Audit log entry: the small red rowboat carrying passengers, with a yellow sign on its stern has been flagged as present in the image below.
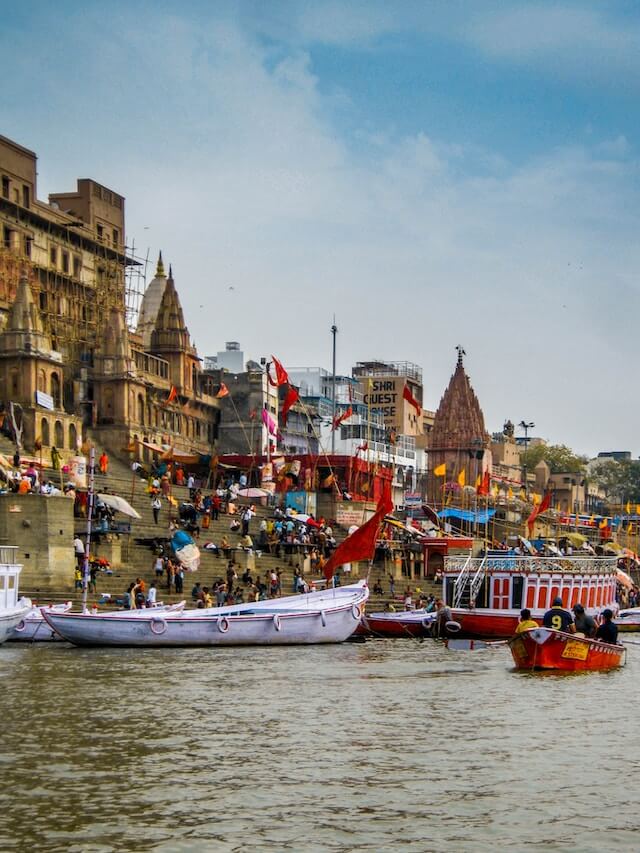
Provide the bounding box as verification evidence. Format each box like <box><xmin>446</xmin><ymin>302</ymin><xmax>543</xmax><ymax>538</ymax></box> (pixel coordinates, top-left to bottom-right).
<box><xmin>509</xmin><ymin>628</ymin><xmax>626</xmax><ymax>672</ymax></box>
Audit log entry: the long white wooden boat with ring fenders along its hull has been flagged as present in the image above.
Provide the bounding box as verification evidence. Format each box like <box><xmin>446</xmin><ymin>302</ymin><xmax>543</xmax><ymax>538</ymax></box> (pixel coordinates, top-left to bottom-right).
<box><xmin>44</xmin><ymin>581</ymin><xmax>369</xmax><ymax>646</ymax></box>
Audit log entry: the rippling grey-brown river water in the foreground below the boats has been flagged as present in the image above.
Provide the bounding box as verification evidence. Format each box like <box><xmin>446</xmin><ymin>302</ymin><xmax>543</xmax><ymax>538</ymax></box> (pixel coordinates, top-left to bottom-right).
<box><xmin>0</xmin><ymin>640</ymin><xmax>640</xmax><ymax>853</ymax></box>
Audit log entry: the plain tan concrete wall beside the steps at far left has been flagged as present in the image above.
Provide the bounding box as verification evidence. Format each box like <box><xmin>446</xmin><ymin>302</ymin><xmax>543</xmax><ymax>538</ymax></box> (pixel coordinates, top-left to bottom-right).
<box><xmin>0</xmin><ymin>494</ymin><xmax>75</xmax><ymax>592</ymax></box>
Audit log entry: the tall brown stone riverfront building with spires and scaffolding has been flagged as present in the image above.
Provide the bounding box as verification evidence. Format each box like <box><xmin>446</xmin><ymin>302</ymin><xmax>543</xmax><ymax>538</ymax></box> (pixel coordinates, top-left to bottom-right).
<box><xmin>0</xmin><ymin>137</ymin><xmax>218</xmax><ymax>458</ymax></box>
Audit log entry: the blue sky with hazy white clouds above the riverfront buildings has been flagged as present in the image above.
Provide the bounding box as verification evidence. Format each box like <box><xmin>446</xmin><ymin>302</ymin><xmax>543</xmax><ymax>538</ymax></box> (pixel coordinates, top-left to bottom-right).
<box><xmin>0</xmin><ymin>0</ymin><xmax>640</xmax><ymax>456</ymax></box>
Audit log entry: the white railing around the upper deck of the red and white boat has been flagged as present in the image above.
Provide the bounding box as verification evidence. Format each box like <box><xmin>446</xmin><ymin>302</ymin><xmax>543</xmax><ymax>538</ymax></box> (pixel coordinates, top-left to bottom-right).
<box><xmin>444</xmin><ymin>554</ymin><xmax>618</xmax><ymax>576</ymax></box>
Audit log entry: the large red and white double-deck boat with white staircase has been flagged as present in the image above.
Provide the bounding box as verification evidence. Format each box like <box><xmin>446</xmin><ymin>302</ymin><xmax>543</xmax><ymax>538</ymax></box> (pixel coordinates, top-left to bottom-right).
<box><xmin>443</xmin><ymin>554</ymin><xmax>618</xmax><ymax>639</ymax></box>
